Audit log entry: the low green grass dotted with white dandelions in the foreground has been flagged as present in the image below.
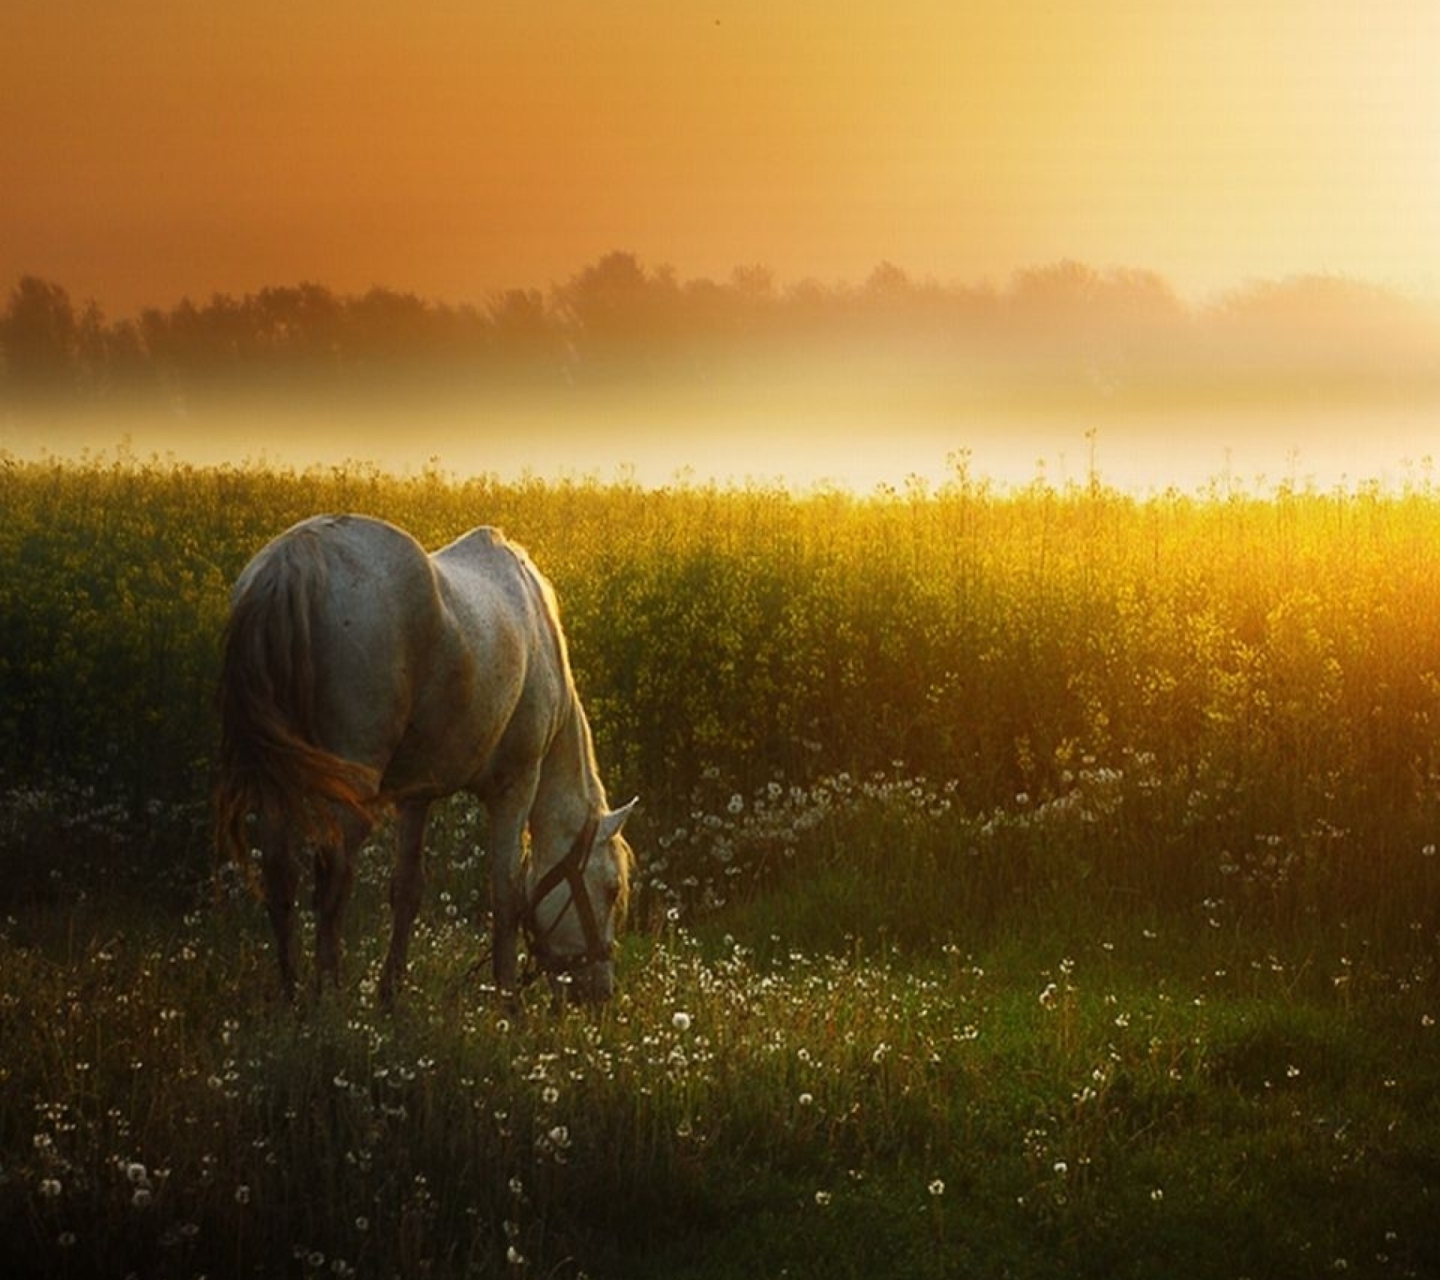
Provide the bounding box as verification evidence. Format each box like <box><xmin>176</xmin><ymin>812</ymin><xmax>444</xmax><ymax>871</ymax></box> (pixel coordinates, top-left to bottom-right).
<box><xmin>0</xmin><ymin>789</ymin><xmax>1440</xmax><ymax>1277</ymax></box>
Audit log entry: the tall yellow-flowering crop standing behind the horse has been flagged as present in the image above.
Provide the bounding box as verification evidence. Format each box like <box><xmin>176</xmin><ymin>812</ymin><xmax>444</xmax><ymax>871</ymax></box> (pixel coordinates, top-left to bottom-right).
<box><xmin>8</xmin><ymin>455</ymin><xmax>1440</xmax><ymax>831</ymax></box>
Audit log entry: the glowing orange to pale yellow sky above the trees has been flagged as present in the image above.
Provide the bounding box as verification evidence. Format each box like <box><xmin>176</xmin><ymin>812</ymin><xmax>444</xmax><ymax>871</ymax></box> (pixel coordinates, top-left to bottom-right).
<box><xmin>0</xmin><ymin>0</ymin><xmax>1440</xmax><ymax>315</ymax></box>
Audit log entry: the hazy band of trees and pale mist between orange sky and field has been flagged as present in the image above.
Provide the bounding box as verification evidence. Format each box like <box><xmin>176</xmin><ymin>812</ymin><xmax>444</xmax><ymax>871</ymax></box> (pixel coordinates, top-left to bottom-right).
<box><xmin>0</xmin><ymin>252</ymin><xmax>1440</xmax><ymax>492</ymax></box>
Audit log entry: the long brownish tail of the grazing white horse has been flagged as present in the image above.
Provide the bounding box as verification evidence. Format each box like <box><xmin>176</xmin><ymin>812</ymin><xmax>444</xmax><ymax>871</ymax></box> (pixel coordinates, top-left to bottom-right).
<box><xmin>215</xmin><ymin>538</ymin><xmax>379</xmax><ymax>867</ymax></box>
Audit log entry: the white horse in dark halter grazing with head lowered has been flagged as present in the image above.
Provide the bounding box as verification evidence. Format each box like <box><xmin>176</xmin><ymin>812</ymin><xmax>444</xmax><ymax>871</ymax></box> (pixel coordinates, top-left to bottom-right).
<box><xmin>216</xmin><ymin>515</ymin><xmax>636</xmax><ymax>1004</ymax></box>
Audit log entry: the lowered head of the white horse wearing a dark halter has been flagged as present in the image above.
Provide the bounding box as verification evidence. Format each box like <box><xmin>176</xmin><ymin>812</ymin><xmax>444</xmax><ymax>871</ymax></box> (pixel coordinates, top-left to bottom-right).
<box><xmin>526</xmin><ymin>801</ymin><xmax>636</xmax><ymax>1002</ymax></box>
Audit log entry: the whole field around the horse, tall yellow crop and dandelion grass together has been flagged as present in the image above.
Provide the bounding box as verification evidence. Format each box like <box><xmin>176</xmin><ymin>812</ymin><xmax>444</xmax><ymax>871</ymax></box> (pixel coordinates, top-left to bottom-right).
<box><xmin>0</xmin><ymin>455</ymin><xmax>1440</xmax><ymax>1280</ymax></box>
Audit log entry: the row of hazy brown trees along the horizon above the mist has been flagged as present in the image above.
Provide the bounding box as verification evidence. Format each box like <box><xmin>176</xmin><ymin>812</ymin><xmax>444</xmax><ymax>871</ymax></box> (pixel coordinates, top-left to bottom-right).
<box><xmin>0</xmin><ymin>252</ymin><xmax>1440</xmax><ymax>402</ymax></box>
